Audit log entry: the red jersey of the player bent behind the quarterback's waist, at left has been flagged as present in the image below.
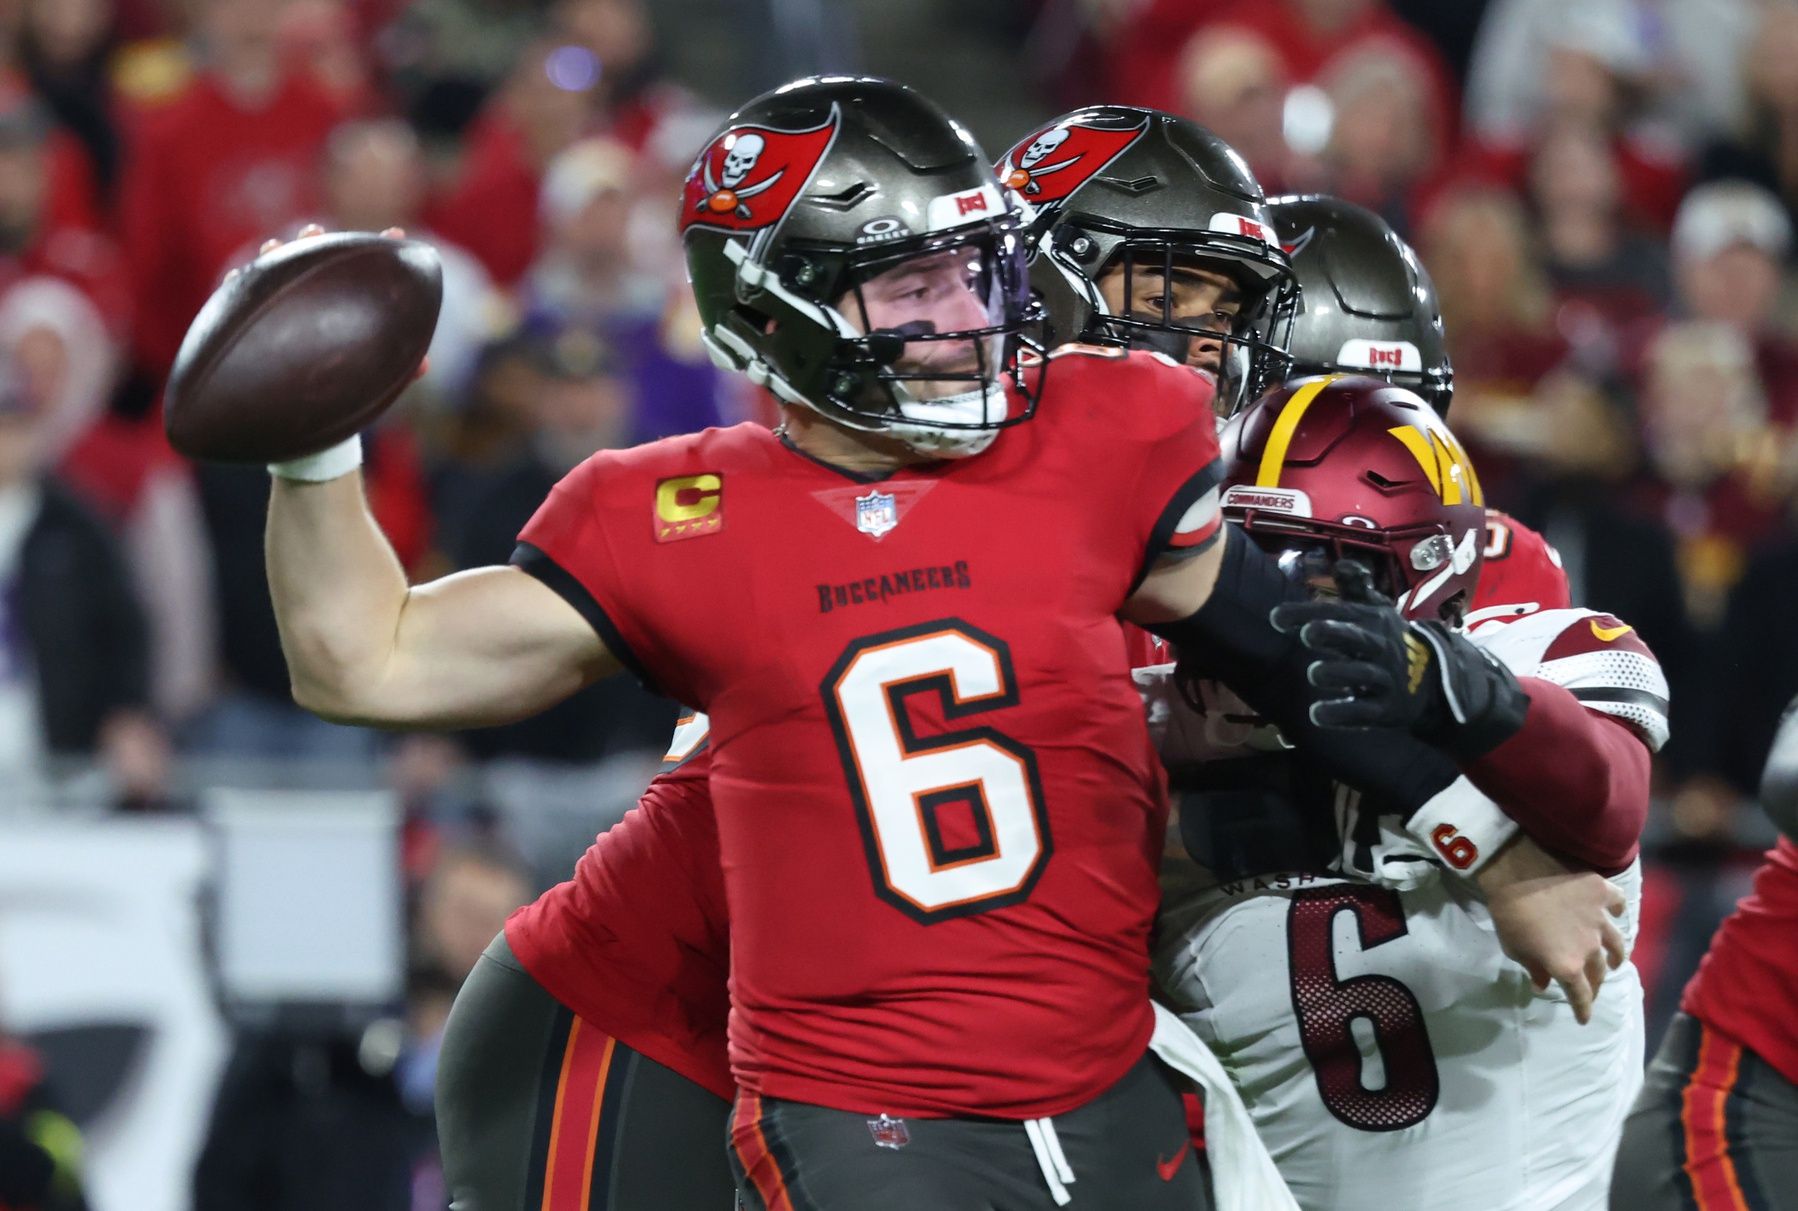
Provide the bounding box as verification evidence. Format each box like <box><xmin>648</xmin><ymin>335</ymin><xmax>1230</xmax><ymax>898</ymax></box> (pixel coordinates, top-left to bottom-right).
<box><xmin>505</xmin><ymin>715</ymin><xmax>735</xmax><ymax>1101</ymax></box>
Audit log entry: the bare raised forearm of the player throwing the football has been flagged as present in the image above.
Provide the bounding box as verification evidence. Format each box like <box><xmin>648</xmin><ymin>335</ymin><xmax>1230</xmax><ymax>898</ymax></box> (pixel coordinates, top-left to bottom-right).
<box><xmin>266</xmin><ymin>471</ymin><xmax>406</xmax><ymax>719</ymax></box>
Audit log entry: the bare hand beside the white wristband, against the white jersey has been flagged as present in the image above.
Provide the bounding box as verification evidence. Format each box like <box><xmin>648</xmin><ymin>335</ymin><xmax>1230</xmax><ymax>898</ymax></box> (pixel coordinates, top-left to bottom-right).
<box><xmin>1474</xmin><ymin>834</ymin><xmax>1625</xmax><ymax>1026</ymax></box>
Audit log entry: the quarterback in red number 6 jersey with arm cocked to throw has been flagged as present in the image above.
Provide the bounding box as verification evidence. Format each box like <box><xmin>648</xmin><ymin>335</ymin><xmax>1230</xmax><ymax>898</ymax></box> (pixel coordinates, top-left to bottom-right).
<box><xmin>268</xmin><ymin>77</ymin><xmax>1433</xmax><ymax>1207</ymax></box>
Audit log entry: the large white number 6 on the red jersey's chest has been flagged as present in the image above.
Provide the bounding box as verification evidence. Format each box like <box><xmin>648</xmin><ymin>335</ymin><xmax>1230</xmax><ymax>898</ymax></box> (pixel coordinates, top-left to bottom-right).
<box><xmin>822</xmin><ymin>620</ymin><xmax>1052</xmax><ymax>924</ymax></box>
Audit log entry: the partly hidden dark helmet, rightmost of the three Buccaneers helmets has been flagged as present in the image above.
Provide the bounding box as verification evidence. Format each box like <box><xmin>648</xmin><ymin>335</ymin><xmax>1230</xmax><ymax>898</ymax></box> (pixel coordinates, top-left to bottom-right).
<box><xmin>1268</xmin><ymin>194</ymin><xmax>1455</xmax><ymax>417</ymax></box>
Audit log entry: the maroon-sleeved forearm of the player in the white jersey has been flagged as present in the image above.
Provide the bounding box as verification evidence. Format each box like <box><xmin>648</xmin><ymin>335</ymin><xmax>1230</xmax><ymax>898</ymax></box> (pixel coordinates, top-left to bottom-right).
<box><xmin>1462</xmin><ymin>677</ymin><xmax>1649</xmax><ymax>871</ymax></box>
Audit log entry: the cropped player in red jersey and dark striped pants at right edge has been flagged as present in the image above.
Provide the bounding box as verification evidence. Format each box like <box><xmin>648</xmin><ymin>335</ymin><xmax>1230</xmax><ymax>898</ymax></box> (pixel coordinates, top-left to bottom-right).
<box><xmin>1611</xmin><ymin>703</ymin><xmax>1798</xmax><ymax>1211</ymax></box>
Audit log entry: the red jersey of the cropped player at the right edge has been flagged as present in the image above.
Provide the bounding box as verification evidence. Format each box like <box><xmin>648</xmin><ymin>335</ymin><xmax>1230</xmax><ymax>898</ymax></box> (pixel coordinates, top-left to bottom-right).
<box><xmin>1679</xmin><ymin>837</ymin><xmax>1798</xmax><ymax>1083</ymax></box>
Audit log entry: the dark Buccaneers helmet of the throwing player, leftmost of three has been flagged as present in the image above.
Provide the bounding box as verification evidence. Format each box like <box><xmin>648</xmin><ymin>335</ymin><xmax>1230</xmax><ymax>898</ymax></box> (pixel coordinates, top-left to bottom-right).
<box><xmin>680</xmin><ymin>75</ymin><xmax>1041</xmax><ymax>456</ymax></box>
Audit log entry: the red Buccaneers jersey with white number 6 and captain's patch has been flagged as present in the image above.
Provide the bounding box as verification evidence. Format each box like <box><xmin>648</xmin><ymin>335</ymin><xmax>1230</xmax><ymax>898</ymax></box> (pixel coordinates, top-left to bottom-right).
<box><xmin>516</xmin><ymin>346</ymin><xmax>1219</xmax><ymax>1118</ymax></box>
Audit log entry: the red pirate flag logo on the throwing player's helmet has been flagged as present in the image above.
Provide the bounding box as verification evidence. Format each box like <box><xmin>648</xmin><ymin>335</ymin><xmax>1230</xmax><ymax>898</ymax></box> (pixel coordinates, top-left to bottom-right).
<box><xmin>680</xmin><ymin>108</ymin><xmax>836</xmax><ymax>232</ymax></box>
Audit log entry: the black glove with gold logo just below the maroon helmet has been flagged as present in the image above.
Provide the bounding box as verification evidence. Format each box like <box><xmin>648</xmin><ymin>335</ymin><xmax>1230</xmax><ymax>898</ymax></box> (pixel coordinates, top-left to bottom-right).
<box><xmin>1273</xmin><ymin>559</ymin><xmax>1530</xmax><ymax>760</ymax></box>
